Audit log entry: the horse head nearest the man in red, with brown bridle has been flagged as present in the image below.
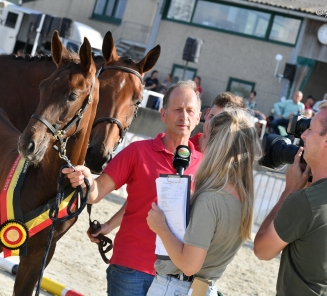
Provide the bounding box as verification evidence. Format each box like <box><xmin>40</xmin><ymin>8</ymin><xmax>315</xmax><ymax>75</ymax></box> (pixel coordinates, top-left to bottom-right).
<box><xmin>85</xmin><ymin>32</ymin><xmax>160</xmax><ymax>173</ymax></box>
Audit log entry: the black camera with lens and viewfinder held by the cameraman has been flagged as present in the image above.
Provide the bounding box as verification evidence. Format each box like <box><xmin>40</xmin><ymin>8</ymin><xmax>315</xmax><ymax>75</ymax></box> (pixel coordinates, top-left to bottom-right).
<box><xmin>259</xmin><ymin>115</ymin><xmax>311</xmax><ymax>170</ymax></box>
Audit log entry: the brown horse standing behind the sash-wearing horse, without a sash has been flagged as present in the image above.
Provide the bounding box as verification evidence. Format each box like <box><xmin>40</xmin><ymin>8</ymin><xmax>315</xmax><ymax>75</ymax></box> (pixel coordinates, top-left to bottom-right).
<box><xmin>0</xmin><ymin>32</ymin><xmax>160</xmax><ymax>173</ymax></box>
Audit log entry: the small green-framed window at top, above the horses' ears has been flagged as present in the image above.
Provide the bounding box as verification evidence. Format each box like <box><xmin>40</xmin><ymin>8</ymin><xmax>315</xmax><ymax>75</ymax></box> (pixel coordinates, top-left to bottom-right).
<box><xmin>92</xmin><ymin>0</ymin><xmax>127</xmax><ymax>24</ymax></box>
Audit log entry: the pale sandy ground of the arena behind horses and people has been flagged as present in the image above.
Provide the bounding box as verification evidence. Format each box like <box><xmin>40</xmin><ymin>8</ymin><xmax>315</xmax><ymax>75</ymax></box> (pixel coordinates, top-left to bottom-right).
<box><xmin>0</xmin><ymin>186</ymin><xmax>279</xmax><ymax>296</ymax></box>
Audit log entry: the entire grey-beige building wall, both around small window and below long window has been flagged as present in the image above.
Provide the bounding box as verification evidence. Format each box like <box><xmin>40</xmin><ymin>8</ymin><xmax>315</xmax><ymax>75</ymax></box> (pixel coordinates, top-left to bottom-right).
<box><xmin>24</xmin><ymin>0</ymin><xmax>300</xmax><ymax>115</ymax></box>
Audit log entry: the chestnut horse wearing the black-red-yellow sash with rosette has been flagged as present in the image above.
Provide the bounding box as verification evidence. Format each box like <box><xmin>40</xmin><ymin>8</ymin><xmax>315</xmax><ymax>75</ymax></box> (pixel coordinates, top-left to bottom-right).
<box><xmin>0</xmin><ymin>32</ymin><xmax>99</xmax><ymax>296</ymax></box>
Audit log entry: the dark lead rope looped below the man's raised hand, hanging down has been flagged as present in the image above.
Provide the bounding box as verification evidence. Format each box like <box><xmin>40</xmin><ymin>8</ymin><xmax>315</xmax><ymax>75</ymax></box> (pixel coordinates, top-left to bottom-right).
<box><xmin>35</xmin><ymin>163</ymin><xmax>90</xmax><ymax>296</ymax></box>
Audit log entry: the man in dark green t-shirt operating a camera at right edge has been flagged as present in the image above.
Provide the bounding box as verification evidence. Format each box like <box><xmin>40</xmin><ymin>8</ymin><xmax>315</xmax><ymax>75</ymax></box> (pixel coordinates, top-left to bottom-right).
<box><xmin>254</xmin><ymin>102</ymin><xmax>327</xmax><ymax>296</ymax></box>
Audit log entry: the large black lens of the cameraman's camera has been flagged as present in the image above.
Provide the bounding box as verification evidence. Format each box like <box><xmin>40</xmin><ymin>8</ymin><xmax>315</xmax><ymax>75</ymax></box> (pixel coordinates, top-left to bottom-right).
<box><xmin>259</xmin><ymin>133</ymin><xmax>305</xmax><ymax>170</ymax></box>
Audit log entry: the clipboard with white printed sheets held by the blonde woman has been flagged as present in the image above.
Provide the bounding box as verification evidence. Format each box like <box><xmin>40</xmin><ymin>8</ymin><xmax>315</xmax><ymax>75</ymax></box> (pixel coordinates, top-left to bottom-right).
<box><xmin>155</xmin><ymin>174</ymin><xmax>191</xmax><ymax>260</ymax></box>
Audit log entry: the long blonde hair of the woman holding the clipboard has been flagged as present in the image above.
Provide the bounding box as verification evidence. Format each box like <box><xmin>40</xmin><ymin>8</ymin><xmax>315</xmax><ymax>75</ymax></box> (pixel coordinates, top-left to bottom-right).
<box><xmin>193</xmin><ymin>108</ymin><xmax>261</xmax><ymax>241</ymax></box>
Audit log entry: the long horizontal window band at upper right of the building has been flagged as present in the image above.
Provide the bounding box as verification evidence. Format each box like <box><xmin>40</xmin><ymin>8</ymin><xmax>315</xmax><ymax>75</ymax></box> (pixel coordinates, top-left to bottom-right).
<box><xmin>164</xmin><ymin>0</ymin><xmax>302</xmax><ymax>46</ymax></box>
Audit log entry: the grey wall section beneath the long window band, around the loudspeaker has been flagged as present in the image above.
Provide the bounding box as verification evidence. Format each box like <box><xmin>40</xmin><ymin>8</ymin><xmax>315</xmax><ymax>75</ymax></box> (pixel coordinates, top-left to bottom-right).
<box><xmin>155</xmin><ymin>21</ymin><xmax>293</xmax><ymax>115</ymax></box>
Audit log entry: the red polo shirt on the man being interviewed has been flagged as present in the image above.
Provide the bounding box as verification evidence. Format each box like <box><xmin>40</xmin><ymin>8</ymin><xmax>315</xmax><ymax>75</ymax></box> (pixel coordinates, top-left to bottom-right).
<box><xmin>103</xmin><ymin>133</ymin><xmax>202</xmax><ymax>275</ymax></box>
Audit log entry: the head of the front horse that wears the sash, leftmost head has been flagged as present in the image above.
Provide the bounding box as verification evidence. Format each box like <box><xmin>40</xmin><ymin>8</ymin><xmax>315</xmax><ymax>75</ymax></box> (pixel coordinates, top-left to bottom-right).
<box><xmin>18</xmin><ymin>31</ymin><xmax>99</xmax><ymax>164</ymax></box>
